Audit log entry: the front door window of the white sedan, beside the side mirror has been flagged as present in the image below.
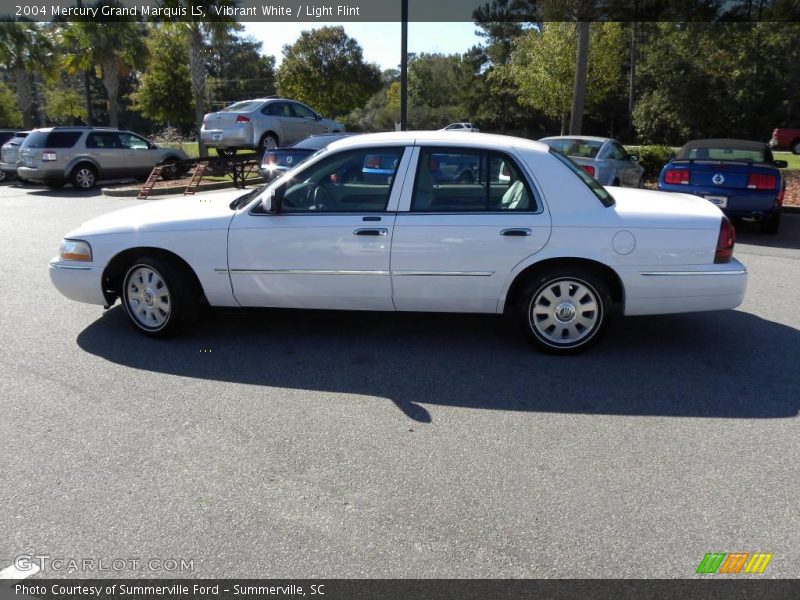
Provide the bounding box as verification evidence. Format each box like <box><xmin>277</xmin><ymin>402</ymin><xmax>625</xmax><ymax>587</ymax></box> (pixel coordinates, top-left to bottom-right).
<box><xmin>281</xmin><ymin>148</ymin><xmax>403</xmax><ymax>213</ymax></box>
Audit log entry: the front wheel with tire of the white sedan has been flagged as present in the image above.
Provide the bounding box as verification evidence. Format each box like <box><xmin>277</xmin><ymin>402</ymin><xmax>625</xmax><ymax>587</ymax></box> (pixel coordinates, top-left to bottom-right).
<box><xmin>120</xmin><ymin>256</ymin><xmax>202</xmax><ymax>338</ymax></box>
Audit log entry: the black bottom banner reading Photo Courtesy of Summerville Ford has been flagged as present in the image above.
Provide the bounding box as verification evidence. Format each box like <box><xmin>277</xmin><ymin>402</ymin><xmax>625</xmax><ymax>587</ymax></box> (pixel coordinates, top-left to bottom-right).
<box><xmin>0</xmin><ymin>576</ymin><xmax>800</xmax><ymax>600</ymax></box>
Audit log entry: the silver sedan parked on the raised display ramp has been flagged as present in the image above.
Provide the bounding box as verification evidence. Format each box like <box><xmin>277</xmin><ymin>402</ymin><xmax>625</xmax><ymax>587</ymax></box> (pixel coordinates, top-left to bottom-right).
<box><xmin>200</xmin><ymin>98</ymin><xmax>344</xmax><ymax>156</ymax></box>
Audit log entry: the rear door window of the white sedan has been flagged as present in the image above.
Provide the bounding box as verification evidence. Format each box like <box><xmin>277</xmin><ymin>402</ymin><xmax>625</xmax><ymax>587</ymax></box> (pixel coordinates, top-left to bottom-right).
<box><xmin>411</xmin><ymin>148</ymin><xmax>537</xmax><ymax>212</ymax></box>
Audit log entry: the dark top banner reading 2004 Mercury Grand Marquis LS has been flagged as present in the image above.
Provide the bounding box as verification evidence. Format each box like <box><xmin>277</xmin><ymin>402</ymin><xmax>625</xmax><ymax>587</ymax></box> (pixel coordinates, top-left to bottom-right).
<box><xmin>0</xmin><ymin>0</ymin><xmax>800</xmax><ymax>24</ymax></box>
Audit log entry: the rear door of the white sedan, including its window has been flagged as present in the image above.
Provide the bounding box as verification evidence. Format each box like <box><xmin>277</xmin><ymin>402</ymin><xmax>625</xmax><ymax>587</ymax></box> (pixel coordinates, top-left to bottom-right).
<box><xmin>392</xmin><ymin>146</ymin><xmax>550</xmax><ymax>312</ymax></box>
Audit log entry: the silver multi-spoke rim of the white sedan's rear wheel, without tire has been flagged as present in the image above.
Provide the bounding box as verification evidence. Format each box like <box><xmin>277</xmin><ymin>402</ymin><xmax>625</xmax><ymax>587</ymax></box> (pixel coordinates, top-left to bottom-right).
<box><xmin>529</xmin><ymin>279</ymin><xmax>601</xmax><ymax>346</ymax></box>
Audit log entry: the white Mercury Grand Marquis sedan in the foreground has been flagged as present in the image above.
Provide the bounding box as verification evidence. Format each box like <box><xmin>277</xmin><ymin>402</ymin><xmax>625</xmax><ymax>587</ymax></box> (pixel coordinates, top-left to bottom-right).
<box><xmin>50</xmin><ymin>132</ymin><xmax>747</xmax><ymax>353</ymax></box>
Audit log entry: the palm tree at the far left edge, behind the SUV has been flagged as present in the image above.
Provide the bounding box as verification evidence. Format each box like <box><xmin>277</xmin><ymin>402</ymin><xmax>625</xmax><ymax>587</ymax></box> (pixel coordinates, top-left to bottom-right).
<box><xmin>0</xmin><ymin>20</ymin><xmax>52</xmax><ymax>129</ymax></box>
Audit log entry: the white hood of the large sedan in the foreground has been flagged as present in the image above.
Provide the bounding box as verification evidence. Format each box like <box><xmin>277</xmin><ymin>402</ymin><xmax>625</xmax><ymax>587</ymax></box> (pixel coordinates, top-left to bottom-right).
<box><xmin>66</xmin><ymin>190</ymin><xmax>247</xmax><ymax>238</ymax></box>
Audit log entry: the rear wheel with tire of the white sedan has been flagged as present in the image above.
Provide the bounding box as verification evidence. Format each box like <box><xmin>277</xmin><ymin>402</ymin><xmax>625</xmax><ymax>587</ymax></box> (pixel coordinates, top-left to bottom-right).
<box><xmin>517</xmin><ymin>267</ymin><xmax>611</xmax><ymax>354</ymax></box>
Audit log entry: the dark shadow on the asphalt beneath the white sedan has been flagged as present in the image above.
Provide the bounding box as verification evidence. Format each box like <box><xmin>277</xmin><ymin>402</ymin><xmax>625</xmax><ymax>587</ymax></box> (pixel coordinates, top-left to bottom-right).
<box><xmin>77</xmin><ymin>306</ymin><xmax>800</xmax><ymax>423</ymax></box>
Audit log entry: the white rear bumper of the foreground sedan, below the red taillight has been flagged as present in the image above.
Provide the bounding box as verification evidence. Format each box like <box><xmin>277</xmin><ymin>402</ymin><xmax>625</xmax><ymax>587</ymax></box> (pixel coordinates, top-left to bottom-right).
<box><xmin>620</xmin><ymin>259</ymin><xmax>747</xmax><ymax>315</ymax></box>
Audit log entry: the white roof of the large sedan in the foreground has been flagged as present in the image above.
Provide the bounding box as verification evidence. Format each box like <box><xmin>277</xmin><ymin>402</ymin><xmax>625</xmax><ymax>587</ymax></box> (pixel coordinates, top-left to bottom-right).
<box><xmin>328</xmin><ymin>131</ymin><xmax>550</xmax><ymax>152</ymax></box>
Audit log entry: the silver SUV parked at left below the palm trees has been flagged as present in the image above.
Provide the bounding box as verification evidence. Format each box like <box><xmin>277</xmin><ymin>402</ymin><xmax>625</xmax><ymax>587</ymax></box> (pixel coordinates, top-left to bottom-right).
<box><xmin>17</xmin><ymin>127</ymin><xmax>186</xmax><ymax>190</ymax></box>
